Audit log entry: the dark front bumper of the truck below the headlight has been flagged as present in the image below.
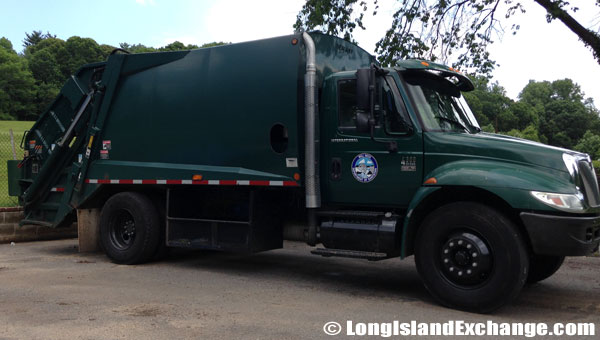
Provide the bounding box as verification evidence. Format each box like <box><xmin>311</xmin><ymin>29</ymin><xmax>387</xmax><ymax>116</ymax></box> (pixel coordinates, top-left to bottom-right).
<box><xmin>521</xmin><ymin>212</ymin><xmax>600</xmax><ymax>256</ymax></box>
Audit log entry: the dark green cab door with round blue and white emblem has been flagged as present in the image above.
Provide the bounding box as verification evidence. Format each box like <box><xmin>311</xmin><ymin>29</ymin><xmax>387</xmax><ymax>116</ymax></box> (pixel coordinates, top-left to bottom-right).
<box><xmin>321</xmin><ymin>75</ymin><xmax>423</xmax><ymax>207</ymax></box>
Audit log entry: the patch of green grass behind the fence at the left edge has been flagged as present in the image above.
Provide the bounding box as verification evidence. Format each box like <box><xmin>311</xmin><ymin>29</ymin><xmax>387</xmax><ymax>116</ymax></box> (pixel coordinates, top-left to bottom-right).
<box><xmin>0</xmin><ymin>120</ymin><xmax>34</xmax><ymax>207</ymax></box>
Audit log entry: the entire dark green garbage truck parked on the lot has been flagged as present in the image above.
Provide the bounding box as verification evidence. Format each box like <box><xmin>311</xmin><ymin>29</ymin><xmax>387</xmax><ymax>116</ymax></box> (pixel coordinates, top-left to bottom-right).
<box><xmin>8</xmin><ymin>33</ymin><xmax>600</xmax><ymax>312</ymax></box>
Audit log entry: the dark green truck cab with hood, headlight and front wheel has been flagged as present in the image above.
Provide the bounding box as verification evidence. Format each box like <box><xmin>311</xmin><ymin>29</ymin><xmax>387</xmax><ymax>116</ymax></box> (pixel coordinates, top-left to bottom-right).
<box><xmin>320</xmin><ymin>60</ymin><xmax>600</xmax><ymax>311</ymax></box>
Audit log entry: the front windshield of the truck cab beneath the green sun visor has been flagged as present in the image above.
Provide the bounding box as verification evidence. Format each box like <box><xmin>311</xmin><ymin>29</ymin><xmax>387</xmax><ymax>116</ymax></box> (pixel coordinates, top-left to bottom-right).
<box><xmin>402</xmin><ymin>72</ymin><xmax>481</xmax><ymax>133</ymax></box>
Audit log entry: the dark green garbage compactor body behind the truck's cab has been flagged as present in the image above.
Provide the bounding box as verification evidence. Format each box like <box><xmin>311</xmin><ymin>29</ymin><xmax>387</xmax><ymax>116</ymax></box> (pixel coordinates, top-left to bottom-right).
<box><xmin>13</xmin><ymin>33</ymin><xmax>375</xmax><ymax>226</ymax></box>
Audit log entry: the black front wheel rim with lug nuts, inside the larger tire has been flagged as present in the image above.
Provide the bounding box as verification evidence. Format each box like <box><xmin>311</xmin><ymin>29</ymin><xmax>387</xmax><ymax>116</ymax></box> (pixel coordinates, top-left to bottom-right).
<box><xmin>440</xmin><ymin>231</ymin><xmax>493</xmax><ymax>288</ymax></box>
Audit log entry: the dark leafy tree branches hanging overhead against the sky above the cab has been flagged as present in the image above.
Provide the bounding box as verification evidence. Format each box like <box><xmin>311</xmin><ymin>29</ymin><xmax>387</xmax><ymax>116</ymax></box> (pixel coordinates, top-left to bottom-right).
<box><xmin>294</xmin><ymin>0</ymin><xmax>600</xmax><ymax>76</ymax></box>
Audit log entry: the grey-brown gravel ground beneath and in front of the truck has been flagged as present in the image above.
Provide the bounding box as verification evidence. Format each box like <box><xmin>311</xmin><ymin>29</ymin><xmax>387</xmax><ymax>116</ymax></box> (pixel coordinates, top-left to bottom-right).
<box><xmin>0</xmin><ymin>240</ymin><xmax>600</xmax><ymax>340</ymax></box>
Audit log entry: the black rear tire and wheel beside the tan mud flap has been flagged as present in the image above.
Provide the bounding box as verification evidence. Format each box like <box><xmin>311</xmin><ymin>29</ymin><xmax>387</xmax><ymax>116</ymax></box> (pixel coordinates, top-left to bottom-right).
<box><xmin>100</xmin><ymin>192</ymin><xmax>160</xmax><ymax>264</ymax></box>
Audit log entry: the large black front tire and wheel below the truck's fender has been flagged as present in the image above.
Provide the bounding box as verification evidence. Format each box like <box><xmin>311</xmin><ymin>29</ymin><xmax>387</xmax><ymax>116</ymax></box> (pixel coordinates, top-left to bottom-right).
<box><xmin>415</xmin><ymin>202</ymin><xmax>529</xmax><ymax>313</ymax></box>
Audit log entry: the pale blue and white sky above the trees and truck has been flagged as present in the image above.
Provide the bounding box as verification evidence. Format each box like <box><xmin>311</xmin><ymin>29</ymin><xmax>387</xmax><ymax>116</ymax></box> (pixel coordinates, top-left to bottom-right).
<box><xmin>0</xmin><ymin>0</ymin><xmax>600</xmax><ymax>108</ymax></box>
